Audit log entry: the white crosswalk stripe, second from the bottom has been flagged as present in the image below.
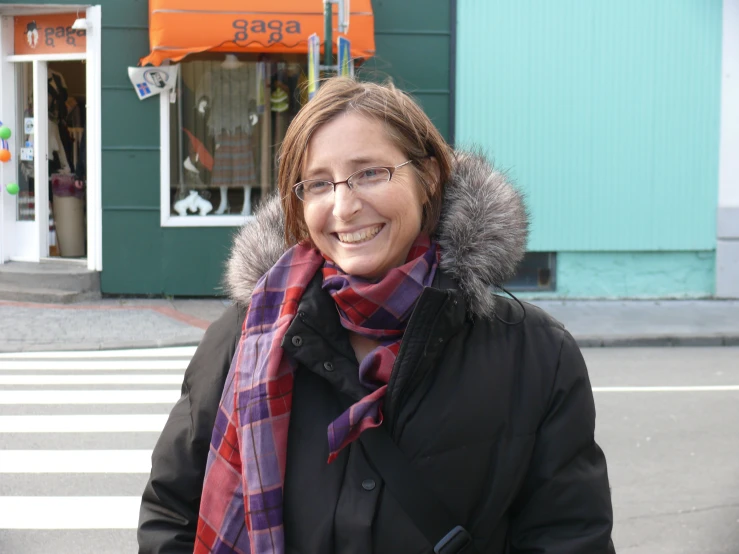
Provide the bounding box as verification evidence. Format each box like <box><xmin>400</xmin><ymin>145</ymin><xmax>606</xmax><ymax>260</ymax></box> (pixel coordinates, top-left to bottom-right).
<box><xmin>0</xmin><ymin>450</ymin><xmax>151</xmax><ymax>474</ymax></box>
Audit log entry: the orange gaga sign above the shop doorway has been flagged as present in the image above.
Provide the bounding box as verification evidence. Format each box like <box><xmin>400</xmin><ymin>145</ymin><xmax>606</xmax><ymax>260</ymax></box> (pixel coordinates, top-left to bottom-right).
<box><xmin>13</xmin><ymin>13</ymin><xmax>87</xmax><ymax>55</ymax></box>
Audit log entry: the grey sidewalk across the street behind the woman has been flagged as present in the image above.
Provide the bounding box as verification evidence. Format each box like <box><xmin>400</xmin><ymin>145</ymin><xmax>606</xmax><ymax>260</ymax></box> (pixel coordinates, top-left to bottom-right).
<box><xmin>0</xmin><ymin>298</ymin><xmax>739</xmax><ymax>352</ymax></box>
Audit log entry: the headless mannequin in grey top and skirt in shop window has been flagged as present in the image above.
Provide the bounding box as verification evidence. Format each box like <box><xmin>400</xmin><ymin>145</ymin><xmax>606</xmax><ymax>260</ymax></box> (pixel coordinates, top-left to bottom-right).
<box><xmin>197</xmin><ymin>54</ymin><xmax>257</xmax><ymax>215</ymax></box>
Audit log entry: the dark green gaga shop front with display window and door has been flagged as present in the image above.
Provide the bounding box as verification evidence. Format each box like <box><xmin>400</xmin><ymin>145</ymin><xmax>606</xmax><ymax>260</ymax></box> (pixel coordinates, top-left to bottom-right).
<box><xmin>0</xmin><ymin>0</ymin><xmax>454</xmax><ymax>296</ymax></box>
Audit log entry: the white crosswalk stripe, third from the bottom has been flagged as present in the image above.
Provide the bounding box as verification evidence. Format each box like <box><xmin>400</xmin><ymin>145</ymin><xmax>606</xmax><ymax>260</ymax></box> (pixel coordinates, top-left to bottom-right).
<box><xmin>0</xmin><ymin>414</ymin><xmax>167</xmax><ymax>432</ymax></box>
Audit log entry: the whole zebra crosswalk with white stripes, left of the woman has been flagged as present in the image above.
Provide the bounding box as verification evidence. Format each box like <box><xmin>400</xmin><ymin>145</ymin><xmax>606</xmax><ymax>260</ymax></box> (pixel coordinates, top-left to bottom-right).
<box><xmin>0</xmin><ymin>347</ymin><xmax>195</xmax><ymax>532</ymax></box>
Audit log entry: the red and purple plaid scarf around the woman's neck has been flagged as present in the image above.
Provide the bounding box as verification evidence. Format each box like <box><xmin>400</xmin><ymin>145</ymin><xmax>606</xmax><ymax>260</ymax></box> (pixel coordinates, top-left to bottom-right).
<box><xmin>194</xmin><ymin>236</ymin><xmax>439</xmax><ymax>554</ymax></box>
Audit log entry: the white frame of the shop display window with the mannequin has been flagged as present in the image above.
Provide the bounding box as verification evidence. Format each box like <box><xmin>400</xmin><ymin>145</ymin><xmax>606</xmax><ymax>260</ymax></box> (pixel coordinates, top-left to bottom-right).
<box><xmin>159</xmin><ymin>86</ymin><xmax>254</xmax><ymax>227</ymax></box>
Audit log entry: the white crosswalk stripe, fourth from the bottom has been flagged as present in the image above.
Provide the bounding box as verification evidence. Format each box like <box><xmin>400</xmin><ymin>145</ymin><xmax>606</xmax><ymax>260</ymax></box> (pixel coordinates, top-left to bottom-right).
<box><xmin>0</xmin><ymin>390</ymin><xmax>180</xmax><ymax>405</ymax></box>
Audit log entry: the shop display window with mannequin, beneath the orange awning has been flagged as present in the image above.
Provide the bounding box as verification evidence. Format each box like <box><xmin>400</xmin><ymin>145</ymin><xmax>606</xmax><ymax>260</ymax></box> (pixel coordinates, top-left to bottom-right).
<box><xmin>163</xmin><ymin>54</ymin><xmax>306</xmax><ymax>222</ymax></box>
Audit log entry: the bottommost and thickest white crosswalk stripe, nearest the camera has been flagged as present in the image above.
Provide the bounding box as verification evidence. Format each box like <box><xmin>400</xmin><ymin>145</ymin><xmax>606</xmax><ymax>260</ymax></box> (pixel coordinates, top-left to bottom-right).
<box><xmin>0</xmin><ymin>496</ymin><xmax>141</xmax><ymax>529</ymax></box>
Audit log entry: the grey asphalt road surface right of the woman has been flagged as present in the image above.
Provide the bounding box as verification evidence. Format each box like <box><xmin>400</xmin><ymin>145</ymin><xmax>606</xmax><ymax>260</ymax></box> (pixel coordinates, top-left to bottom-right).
<box><xmin>583</xmin><ymin>348</ymin><xmax>739</xmax><ymax>554</ymax></box>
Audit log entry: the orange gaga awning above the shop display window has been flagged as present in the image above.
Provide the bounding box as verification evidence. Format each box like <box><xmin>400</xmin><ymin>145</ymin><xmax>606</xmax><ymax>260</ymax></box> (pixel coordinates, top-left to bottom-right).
<box><xmin>141</xmin><ymin>0</ymin><xmax>375</xmax><ymax>65</ymax></box>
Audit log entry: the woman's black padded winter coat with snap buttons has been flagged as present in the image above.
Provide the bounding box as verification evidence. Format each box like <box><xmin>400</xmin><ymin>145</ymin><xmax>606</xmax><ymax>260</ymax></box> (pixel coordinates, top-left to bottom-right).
<box><xmin>139</xmin><ymin>152</ymin><xmax>614</xmax><ymax>554</ymax></box>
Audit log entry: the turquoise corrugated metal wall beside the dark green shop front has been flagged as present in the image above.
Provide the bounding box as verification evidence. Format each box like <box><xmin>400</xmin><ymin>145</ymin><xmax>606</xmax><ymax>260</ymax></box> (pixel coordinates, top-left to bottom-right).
<box><xmin>456</xmin><ymin>0</ymin><xmax>721</xmax><ymax>251</ymax></box>
